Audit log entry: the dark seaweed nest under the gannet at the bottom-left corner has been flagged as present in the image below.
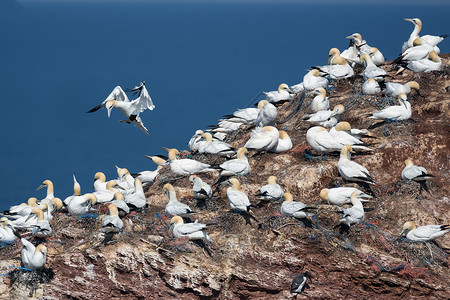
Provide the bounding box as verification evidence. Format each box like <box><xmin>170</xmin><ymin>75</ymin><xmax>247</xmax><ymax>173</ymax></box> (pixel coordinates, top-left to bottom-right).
<box><xmin>8</xmin><ymin>268</ymin><xmax>55</xmax><ymax>297</ymax></box>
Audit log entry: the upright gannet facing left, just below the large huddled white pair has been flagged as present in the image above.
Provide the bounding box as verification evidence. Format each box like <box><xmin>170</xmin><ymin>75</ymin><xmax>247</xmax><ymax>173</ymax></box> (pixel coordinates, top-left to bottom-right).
<box><xmin>337</xmin><ymin>145</ymin><xmax>375</xmax><ymax>184</ymax></box>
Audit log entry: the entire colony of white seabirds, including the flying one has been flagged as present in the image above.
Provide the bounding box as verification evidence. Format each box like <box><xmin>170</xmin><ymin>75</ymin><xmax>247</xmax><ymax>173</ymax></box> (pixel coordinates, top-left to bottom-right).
<box><xmin>0</xmin><ymin>18</ymin><xmax>450</xmax><ymax>293</ymax></box>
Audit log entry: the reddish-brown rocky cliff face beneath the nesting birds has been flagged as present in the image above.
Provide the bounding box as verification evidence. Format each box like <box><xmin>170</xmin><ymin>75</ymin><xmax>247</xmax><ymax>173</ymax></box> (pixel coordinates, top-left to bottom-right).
<box><xmin>0</xmin><ymin>56</ymin><xmax>450</xmax><ymax>299</ymax></box>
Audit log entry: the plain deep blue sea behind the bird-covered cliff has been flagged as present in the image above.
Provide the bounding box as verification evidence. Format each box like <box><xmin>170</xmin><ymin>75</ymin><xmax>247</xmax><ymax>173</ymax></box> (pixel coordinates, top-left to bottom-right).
<box><xmin>0</xmin><ymin>0</ymin><xmax>450</xmax><ymax>209</ymax></box>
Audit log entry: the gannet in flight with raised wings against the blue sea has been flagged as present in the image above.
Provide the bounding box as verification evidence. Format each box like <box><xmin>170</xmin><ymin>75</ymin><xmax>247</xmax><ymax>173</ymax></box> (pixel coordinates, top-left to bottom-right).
<box><xmin>88</xmin><ymin>82</ymin><xmax>155</xmax><ymax>134</ymax></box>
